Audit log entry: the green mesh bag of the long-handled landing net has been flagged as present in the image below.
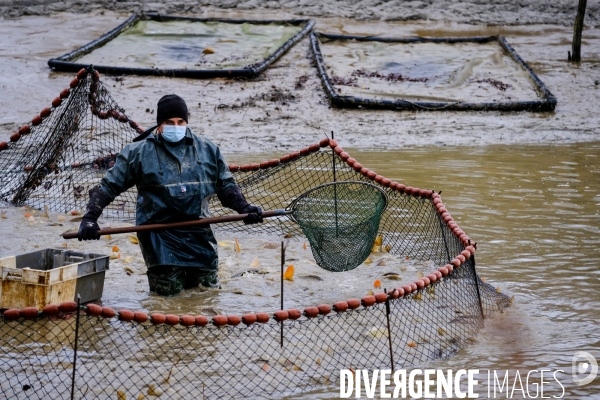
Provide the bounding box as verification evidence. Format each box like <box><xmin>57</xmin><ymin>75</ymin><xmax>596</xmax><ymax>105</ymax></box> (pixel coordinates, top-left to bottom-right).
<box><xmin>290</xmin><ymin>181</ymin><xmax>387</xmax><ymax>272</ymax></box>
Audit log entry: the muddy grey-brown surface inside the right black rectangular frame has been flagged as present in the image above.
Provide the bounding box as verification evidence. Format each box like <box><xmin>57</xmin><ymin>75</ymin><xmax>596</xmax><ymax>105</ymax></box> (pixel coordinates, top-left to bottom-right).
<box><xmin>320</xmin><ymin>38</ymin><xmax>538</xmax><ymax>103</ymax></box>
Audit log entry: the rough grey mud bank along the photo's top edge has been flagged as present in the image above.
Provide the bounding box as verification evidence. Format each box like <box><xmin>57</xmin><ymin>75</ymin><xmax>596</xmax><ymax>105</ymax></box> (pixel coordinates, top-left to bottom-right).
<box><xmin>0</xmin><ymin>0</ymin><xmax>600</xmax><ymax>26</ymax></box>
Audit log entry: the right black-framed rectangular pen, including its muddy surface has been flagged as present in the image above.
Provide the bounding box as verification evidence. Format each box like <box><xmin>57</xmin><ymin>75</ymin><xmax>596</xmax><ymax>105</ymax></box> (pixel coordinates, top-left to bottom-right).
<box><xmin>310</xmin><ymin>32</ymin><xmax>557</xmax><ymax>111</ymax></box>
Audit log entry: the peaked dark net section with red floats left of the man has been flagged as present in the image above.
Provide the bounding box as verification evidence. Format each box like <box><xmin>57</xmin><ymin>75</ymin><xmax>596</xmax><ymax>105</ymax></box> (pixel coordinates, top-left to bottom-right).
<box><xmin>0</xmin><ymin>68</ymin><xmax>143</xmax><ymax>220</ymax></box>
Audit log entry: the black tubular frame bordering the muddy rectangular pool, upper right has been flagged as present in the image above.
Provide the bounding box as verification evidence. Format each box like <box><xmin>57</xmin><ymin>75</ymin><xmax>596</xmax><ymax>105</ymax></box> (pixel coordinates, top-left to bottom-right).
<box><xmin>310</xmin><ymin>32</ymin><xmax>557</xmax><ymax>112</ymax></box>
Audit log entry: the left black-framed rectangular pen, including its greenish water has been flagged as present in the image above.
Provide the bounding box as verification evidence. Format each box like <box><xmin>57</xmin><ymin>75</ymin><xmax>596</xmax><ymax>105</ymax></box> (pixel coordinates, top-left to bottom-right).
<box><xmin>48</xmin><ymin>14</ymin><xmax>315</xmax><ymax>79</ymax></box>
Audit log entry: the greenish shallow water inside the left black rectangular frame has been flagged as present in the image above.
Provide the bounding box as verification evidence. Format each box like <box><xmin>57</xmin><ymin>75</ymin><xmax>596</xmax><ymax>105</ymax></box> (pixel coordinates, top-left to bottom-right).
<box><xmin>76</xmin><ymin>21</ymin><xmax>302</xmax><ymax>69</ymax></box>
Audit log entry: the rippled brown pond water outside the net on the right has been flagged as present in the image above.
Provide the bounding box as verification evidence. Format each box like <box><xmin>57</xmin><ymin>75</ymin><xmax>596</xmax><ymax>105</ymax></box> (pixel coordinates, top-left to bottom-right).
<box><xmin>230</xmin><ymin>143</ymin><xmax>600</xmax><ymax>399</ymax></box>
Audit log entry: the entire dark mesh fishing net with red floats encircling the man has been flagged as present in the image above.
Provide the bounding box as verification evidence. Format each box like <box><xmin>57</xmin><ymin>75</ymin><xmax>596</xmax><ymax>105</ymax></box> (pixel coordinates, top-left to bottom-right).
<box><xmin>0</xmin><ymin>71</ymin><xmax>510</xmax><ymax>400</ymax></box>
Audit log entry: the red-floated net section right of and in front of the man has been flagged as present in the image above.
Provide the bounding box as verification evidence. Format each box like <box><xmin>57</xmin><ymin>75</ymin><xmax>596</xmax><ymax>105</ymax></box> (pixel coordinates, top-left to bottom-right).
<box><xmin>0</xmin><ymin>139</ymin><xmax>510</xmax><ymax>399</ymax></box>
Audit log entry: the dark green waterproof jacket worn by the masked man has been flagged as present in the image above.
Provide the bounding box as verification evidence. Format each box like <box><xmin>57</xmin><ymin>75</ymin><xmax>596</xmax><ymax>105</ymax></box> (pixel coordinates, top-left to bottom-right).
<box><xmin>100</xmin><ymin>129</ymin><xmax>235</xmax><ymax>274</ymax></box>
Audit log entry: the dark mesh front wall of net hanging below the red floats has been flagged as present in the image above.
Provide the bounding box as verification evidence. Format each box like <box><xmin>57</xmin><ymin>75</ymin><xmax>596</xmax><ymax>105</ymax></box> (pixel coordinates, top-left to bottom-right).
<box><xmin>0</xmin><ymin>263</ymin><xmax>509</xmax><ymax>399</ymax></box>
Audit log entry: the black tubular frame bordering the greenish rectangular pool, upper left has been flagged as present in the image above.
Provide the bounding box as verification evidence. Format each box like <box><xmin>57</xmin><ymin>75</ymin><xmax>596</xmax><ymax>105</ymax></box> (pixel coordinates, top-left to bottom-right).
<box><xmin>48</xmin><ymin>13</ymin><xmax>315</xmax><ymax>79</ymax></box>
